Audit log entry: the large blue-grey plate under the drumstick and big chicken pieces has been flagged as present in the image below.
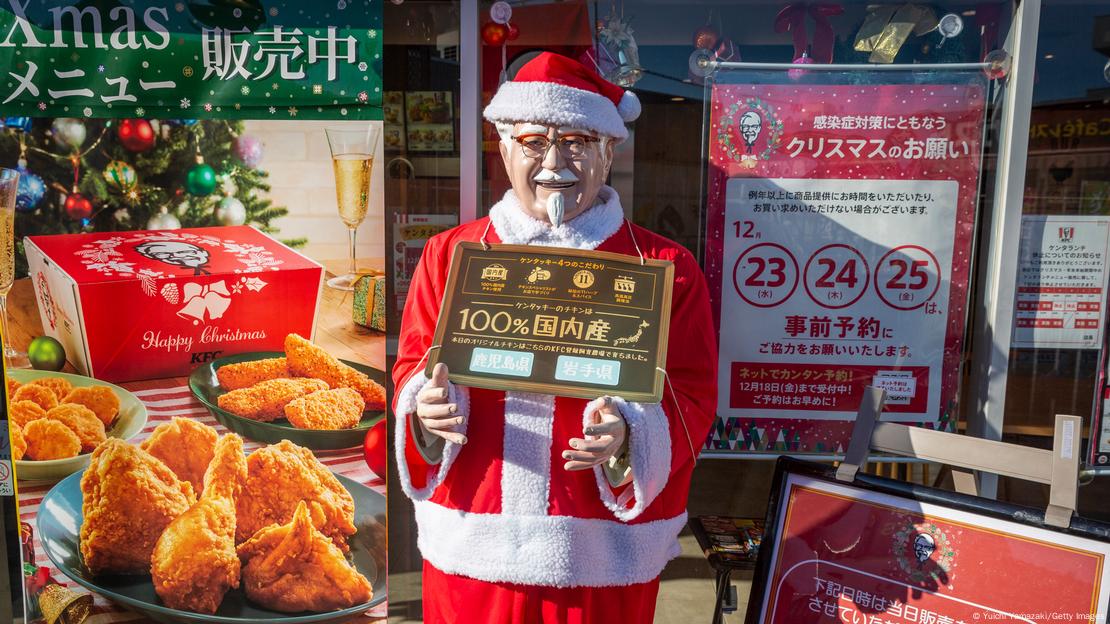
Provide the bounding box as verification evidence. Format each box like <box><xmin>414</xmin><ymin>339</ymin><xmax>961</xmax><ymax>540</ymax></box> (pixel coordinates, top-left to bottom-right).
<box><xmin>37</xmin><ymin>471</ymin><xmax>385</xmax><ymax>624</ymax></box>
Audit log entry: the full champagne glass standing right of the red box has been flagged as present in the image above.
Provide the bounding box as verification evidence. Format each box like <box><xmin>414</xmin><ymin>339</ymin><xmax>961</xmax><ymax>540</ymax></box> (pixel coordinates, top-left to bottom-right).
<box><xmin>324</xmin><ymin>124</ymin><xmax>381</xmax><ymax>290</ymax></box>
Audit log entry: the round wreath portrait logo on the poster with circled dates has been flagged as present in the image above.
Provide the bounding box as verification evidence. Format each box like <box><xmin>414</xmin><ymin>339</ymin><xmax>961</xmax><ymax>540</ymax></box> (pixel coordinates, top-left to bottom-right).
<box><xmin>716</xmin><ymin>98</ymin><xmax>783</xmax><ymax>169</ymax></box>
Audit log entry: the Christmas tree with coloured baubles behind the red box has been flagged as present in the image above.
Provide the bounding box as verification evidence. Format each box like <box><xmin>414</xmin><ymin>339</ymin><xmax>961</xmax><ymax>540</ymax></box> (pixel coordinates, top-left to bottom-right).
<box><xmin>0</xmin><ymin>118</ymin><xmax>305</xmax><ymax>276</ymax></box>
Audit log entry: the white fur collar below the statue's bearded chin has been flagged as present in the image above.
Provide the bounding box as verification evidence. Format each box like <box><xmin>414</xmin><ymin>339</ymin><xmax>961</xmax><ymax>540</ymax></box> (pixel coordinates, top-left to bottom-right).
<box><xmin>490</xmin><ymin>187</ymin><xmax>624</xmax><ymax>249</ymax></box>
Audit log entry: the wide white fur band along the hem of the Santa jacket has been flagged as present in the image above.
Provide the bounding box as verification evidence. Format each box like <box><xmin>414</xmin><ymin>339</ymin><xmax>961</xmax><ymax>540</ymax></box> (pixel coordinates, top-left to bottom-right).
<box><xmin>415</xmin><ymin>501</ymin><xmax>686</xmax><ymax>587</ymax></box>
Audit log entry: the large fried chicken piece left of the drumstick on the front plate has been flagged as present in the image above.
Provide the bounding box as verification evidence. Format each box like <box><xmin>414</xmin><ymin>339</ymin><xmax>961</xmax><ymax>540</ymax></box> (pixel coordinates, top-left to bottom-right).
<box><xmin>81</xmin><ymin>437</ymin><xmax>196</xmax><ymax>574</ymax></box>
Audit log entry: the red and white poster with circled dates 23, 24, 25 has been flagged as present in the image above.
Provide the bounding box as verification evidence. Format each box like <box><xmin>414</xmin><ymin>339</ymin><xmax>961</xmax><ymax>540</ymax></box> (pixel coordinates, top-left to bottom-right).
<box><xmin>706</xmin><ymin>74</ymin><xmax>985</xmax><ymax>453</ymax></box>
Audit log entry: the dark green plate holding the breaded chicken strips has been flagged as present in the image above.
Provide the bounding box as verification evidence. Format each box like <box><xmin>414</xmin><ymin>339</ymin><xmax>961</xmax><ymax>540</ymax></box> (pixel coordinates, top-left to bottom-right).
<box><xmin>189</xmin><ymin>351</ymin><xmax>385</xmax><ymax>451</ymax></box>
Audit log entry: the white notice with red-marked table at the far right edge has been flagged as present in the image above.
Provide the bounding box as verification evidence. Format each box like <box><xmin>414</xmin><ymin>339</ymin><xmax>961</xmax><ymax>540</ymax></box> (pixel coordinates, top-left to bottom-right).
<box><xmin>1012</xmin><ymin>215</ymin><xmax>1110</xmax><ymax>349</ymax></box>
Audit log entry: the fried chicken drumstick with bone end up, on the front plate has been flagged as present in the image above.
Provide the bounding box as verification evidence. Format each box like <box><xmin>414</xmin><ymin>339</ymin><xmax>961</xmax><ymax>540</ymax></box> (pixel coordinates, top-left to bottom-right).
<box><xmin>150</xmin><ymin>433</ymin><xmax>246</xmax><ymax>614</ymax></box>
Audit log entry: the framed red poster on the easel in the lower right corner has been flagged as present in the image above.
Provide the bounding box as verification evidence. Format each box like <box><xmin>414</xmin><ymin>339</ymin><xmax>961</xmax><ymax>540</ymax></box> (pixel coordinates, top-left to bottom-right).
<box><xmin>749</xmin><ymin>474</ymin><xmax>1110</xmax><ymax>624</ymax></box>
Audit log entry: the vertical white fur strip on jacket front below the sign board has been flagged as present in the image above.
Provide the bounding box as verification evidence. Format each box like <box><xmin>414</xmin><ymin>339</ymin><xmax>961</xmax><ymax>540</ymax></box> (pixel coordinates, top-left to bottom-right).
<box><xmin>501</xmin><ymin>392</ymin><xmax>555</xmax><ymax>515</ymax></box>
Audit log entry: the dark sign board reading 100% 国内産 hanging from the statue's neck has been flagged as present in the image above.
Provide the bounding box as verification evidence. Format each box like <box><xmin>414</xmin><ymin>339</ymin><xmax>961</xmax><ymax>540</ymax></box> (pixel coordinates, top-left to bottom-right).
<box><xmin>427</xmin><ymin>242</ymin><xmax>674</xmax><ymax>402</ymax></box>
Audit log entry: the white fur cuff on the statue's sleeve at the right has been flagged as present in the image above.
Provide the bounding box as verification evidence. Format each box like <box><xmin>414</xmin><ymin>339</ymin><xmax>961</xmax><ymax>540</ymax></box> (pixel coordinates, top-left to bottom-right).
<box><xmin>582</xmin><ymin>396</ymin><xmax>670</xmax><ymax>522</ymax></box>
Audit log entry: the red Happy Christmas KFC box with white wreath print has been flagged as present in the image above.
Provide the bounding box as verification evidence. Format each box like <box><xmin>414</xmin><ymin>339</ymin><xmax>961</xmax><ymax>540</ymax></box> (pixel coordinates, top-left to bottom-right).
<box><xmin>24</xmin><ymin>225</ymin><xmax>324</xmax><ymax>382</ymax></box>
